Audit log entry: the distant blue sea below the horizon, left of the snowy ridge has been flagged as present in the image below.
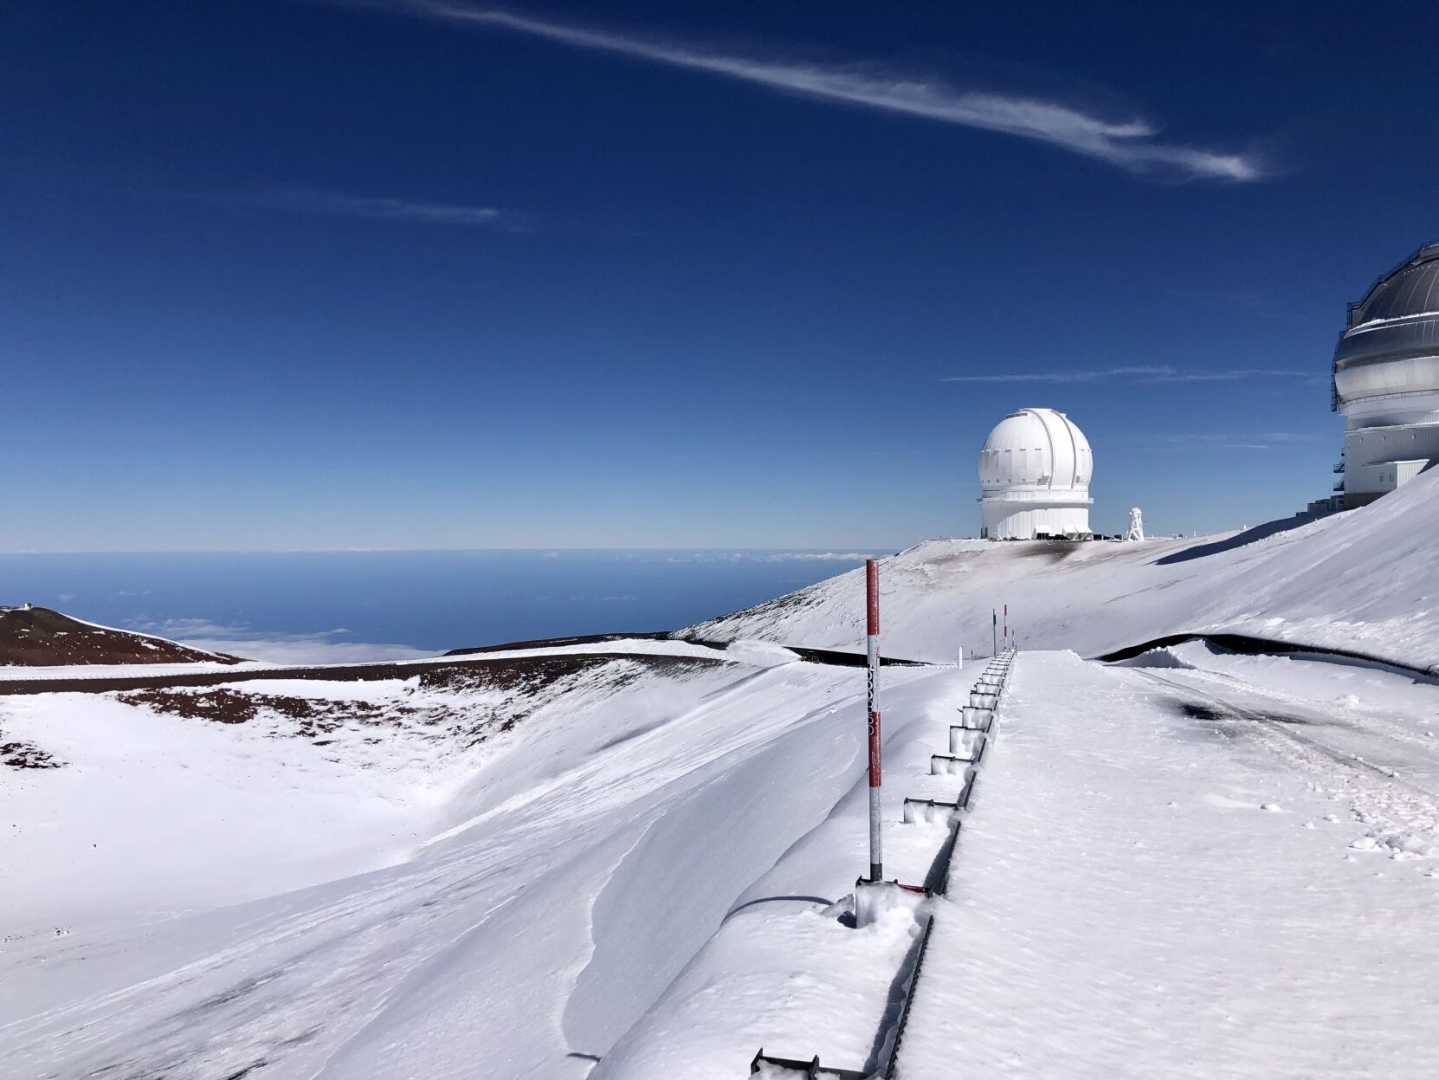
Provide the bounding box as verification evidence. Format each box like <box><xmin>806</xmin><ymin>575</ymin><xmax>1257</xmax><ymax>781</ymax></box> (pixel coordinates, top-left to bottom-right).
<box><xmin>0</xmin><ymin>549</ymin><xmax>886</xmax><ymax>663</ymax></box>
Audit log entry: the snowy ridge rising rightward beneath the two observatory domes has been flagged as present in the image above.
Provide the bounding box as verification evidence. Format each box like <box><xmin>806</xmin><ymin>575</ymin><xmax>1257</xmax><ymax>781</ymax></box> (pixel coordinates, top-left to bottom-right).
<box><xmin>682</xmin><ymin>469</ymin><xmax>1439</xmax><ymax>670</ymax></box>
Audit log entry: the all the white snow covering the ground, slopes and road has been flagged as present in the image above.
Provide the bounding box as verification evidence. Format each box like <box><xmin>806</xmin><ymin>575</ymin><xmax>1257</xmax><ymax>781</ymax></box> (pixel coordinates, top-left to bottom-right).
<box><xmin>0</xmin><ymin>470</ymin><xmax>1439</xmax><ymax>1080</ymax></box>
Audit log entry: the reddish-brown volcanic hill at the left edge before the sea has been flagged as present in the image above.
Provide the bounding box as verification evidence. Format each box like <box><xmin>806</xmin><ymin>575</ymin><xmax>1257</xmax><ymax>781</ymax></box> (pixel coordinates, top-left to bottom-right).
<box><xmin>0</xmin><ymin>607</ymin><xmax>239</xmax><ymax>667</ymax></box>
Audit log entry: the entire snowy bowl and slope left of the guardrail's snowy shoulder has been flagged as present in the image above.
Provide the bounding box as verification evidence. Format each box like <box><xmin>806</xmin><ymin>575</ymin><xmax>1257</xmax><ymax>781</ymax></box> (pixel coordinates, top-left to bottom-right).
<box><xmin>0</xmin><ymin>643</ymin><xmax>948</xmax><ymax>1080</ymax></box>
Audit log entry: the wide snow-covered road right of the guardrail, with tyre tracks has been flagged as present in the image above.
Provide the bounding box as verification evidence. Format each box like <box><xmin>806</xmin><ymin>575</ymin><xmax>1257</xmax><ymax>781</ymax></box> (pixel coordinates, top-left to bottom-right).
<box><xmin>899</xmin><ymin>646</ymin><xmax>1439</xmax><ymax>1080</ymax></box>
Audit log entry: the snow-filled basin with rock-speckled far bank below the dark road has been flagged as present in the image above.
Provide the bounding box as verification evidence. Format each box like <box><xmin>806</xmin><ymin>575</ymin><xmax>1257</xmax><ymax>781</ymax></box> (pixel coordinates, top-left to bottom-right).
<box><xmin>0</xmin><ymin>654</ymin><xmax>735</xmax><ymax>935</ymax></box>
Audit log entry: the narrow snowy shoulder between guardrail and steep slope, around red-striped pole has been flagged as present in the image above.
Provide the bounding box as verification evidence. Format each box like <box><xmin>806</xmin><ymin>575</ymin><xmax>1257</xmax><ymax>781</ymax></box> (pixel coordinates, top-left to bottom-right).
<box><xmin>590</xmin><ymin>667</ymin><xmax>987</xmax><ymax>1080</ymax></box>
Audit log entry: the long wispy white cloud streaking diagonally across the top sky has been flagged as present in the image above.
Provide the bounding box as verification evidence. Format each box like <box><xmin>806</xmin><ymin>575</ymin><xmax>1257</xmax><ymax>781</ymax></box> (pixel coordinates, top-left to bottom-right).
<box><xmin>353</xmin><ymin>0</ymin><xmax>1265</xmax><ymax>181</ymax></box>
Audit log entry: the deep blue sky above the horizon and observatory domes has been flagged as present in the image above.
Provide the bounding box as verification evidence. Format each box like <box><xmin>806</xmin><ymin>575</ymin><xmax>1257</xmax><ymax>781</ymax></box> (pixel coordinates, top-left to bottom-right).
<box><xmin>0</xmin><ymin>0</ymin><xmax>1439</xmax><ymax>551</ymax></box>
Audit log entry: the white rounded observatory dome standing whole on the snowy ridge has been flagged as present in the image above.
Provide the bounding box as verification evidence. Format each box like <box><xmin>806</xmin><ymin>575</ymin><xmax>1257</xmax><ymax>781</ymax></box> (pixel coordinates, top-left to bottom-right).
<box><xmin>980</xmin><ymin>408</ymin><xmax>1094</xmax><ymax>539</ymax></box>
